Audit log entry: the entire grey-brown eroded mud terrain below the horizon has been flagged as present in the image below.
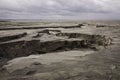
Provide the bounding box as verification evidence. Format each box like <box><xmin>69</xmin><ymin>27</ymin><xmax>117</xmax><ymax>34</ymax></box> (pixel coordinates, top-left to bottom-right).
<box><xmin>0</xmin><ymin>21</ymin><xmax>120</xmax><ymax>80</ymax></box>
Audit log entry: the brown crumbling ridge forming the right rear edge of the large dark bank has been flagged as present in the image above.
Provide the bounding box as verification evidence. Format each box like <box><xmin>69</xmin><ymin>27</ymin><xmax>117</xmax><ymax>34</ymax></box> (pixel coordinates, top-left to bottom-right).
<box><xmin>56</xmin><ymin>33</ymin><xmax>112</xmax><ymax>46</ymax></box>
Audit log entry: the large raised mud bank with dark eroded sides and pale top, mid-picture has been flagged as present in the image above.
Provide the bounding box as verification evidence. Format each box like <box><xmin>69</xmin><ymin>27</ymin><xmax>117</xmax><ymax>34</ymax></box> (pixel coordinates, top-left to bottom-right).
<box><xmin>0</xmin><ymin>29</ymin><xmax>111</xmax><ymax>58</ymax></box>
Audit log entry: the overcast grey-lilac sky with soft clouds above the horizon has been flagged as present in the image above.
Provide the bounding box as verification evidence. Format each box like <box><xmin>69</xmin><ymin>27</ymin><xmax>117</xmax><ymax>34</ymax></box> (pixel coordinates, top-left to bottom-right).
<box><xmin>0</xmin><ymin>0</ymin><xmax>120</xmax><ymax>20</ymax></box>
